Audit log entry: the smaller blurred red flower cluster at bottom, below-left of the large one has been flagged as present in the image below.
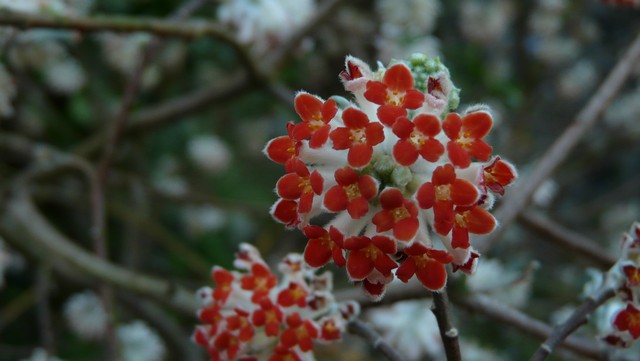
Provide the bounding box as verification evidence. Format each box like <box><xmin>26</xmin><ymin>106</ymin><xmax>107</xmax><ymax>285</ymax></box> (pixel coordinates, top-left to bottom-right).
<box><xmin>193</xmin><ymin>244</ymin><xmax>359</xmax><ymax>361</ymax></box>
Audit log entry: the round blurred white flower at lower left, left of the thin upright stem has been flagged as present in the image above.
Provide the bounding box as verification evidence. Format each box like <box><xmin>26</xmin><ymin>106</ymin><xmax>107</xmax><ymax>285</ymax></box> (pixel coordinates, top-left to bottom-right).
<box><xmin>64</xmin><ymin>291</ymin><xmax>108</xmax><ymax>340</ymax></box>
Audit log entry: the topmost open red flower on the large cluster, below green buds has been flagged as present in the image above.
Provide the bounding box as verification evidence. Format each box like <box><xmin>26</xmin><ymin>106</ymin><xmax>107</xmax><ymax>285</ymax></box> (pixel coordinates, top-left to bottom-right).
<box><xmin>364</xmin><ymin>64</ymin><xmax>424</xmax><ymax>127</ymax></box>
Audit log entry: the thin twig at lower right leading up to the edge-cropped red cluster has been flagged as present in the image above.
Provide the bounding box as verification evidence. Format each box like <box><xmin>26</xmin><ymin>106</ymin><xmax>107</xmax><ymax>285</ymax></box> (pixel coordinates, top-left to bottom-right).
<box><xmin>530</xmin><ymin>287</ymin><xmax>615</xmax><ymax>361</ymax></box>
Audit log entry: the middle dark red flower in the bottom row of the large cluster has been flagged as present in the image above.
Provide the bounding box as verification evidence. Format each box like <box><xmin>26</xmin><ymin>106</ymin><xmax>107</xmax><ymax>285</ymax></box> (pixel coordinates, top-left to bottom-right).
<box><xmin>344</xmin><ymin>236</ymin><xmax>398</xmax><ymax>280</ymax></box>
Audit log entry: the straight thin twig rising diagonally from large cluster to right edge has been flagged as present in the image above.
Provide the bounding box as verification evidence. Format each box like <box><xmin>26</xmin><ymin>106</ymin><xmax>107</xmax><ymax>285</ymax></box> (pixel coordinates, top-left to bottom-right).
<box><xmin>476</xmin><ymin>35</ymin><xmax>640</xmax><ymax>252</ymax></box>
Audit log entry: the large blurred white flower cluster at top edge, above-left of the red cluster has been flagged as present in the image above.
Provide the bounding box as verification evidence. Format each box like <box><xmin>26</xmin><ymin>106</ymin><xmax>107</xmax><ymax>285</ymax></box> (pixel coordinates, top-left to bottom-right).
<box><xmin>218</xmin><ymin>0</ymin><xmax>316</xmax><ymax>54</ymax></box>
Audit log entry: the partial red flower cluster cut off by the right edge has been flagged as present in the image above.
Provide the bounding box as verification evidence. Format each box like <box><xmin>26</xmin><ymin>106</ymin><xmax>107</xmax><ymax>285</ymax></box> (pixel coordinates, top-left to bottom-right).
<box><xmin>603</xmin><ymin>222</ymin><xmax>640</xmax><ymax>347</ymax></box>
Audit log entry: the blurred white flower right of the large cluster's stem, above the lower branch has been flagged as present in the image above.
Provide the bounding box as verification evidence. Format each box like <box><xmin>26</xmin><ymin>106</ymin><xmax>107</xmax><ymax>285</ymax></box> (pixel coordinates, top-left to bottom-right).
<box><xmin>467</xmin><ymin>259</ymin><xmax>536</xmax><ymax>307</ymax></box>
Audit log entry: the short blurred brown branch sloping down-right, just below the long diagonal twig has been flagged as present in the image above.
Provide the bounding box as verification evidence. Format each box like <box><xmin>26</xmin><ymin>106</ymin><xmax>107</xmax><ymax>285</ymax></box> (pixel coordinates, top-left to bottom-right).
<box><xmin>520</xmin><ymin>211</ymin><xmax>616</xmax><ymax>269</ymax></box>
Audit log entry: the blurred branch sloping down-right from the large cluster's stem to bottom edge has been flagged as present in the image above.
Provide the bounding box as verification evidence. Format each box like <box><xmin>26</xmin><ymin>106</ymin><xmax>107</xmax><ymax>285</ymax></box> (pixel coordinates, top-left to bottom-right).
<box><xmin>452</xmin><ymin>295</ymin><xmax>608</xmax><ymax>361</ymax></box>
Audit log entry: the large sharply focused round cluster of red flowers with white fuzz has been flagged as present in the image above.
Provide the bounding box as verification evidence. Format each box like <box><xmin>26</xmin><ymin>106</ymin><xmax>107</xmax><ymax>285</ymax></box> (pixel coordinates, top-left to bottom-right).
<box><xmin>265</xmin><ymin>54</ymin><xmax>517</xmax><ymax>299</ymax></box>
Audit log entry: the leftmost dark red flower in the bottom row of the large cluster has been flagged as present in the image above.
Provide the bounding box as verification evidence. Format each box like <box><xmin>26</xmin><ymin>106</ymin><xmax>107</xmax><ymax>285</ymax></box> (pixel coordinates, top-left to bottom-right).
<box><xmin>303</xmin><ymin>225</ymin><xmax>346</xmax><ymax>267</ymax></box>
